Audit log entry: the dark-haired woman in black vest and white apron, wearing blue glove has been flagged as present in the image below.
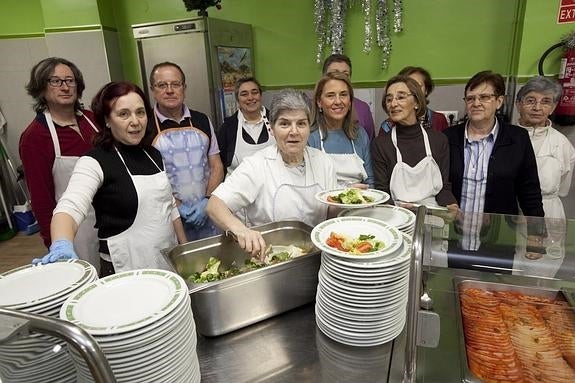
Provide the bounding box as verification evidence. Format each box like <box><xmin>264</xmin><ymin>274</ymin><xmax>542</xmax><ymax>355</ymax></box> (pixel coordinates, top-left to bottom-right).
<box><xmin>34</xmin><ymin>82</ymin><xmax>185</xmax><ymax>276</ymax></box>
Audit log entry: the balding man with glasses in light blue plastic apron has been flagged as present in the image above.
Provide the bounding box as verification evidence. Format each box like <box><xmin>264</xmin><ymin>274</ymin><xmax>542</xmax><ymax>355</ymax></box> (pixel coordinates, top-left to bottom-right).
<box><xmin>149</xmin><ymin>62</ymin><xmax>224</xmax><ymax>241</ymax></box>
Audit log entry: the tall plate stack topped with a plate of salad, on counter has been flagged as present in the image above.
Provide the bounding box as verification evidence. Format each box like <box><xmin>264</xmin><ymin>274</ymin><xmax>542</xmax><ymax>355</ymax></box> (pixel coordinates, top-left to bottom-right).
<box><xmin>311</xmin><ymin>217</ymin><xmax>411</xmax><ymax>347</ymax></box>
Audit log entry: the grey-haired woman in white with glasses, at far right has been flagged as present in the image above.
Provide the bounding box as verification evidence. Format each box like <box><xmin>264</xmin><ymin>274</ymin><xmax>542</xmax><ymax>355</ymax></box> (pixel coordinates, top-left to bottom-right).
<box><xmin>516</xmin><ymin>76</ymin><xmax>575</xmax><ymax>277</ymax></box>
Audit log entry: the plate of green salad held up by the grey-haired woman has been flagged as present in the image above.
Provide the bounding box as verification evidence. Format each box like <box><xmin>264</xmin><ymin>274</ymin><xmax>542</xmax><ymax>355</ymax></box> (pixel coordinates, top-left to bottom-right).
<box><xmin>315</xmin><ymin>188</ymin><xmax>389</xmax><ymax>209</ymax></box>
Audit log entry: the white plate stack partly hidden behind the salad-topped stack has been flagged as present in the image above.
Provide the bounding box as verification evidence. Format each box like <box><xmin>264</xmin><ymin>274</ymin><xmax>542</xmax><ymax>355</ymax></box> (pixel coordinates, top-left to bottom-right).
<box><xmin>339</xmin><ymin>205</ymin><xmax>415</xmax><ymax>237</ymax></box>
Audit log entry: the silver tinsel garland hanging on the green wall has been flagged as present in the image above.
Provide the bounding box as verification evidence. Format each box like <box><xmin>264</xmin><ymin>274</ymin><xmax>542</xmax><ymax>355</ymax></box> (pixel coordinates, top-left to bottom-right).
<box><xmin>314</xmin><ymin>0</ymin><xmax>403</xmax><ymax>69</ymax></box>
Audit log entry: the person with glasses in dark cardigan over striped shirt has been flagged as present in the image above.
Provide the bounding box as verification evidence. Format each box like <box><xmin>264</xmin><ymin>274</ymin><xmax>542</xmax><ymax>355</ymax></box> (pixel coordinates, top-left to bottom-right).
<box><xmin>444</xmin><ymin>71</ymin><xmax>544</xmax><ymax>255</ymax></box>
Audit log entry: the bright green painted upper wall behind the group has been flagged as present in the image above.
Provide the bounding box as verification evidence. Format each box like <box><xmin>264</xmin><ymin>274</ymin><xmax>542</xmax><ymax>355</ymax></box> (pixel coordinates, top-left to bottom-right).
<box><xmin>0</xmin><ymin>0</ymin><xmax>575</xmax><ymax>87</ymax></box>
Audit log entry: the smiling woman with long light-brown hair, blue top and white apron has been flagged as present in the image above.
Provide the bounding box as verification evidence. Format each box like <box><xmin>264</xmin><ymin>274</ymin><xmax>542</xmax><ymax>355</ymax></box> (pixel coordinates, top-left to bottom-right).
<box><xmin>308</xmin><ymin>72</ymin><xmax>373</xmax><ymax>189</ymax></box>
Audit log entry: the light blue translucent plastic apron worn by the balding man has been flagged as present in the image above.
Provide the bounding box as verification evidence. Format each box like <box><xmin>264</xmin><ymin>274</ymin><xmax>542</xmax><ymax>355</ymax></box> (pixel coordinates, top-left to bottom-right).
<box><xmin>153</xmin><ymin>114</ymin><xmax>221</xmax><ymax>241</ymax></box>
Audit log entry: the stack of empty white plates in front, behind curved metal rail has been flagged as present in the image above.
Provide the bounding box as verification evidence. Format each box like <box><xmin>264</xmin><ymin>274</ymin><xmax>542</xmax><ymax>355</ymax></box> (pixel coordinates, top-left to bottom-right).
<box><xmin>60</xmin><ymin>269</ymin><xmax>201</xmax><ymax>383</ymax></box>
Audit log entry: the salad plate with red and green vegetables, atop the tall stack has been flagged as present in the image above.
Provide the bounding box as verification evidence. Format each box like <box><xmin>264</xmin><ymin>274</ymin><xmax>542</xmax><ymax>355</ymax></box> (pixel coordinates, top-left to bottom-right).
<box><xmin>311</xmin><ymin>217</ymin><xmax>403</xmax><ymax>261</ymax></box>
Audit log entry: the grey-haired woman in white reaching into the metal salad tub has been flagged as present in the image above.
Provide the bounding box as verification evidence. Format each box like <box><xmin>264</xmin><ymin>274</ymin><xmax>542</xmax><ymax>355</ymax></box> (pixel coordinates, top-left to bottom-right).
<box><xmin>207</xmin><ymin>89</ymin><xmax>336</xmax><ymax>255</ymax></box>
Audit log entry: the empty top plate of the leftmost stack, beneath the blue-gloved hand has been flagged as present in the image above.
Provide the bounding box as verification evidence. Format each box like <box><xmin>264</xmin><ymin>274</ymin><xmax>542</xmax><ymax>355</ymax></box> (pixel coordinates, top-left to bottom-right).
<box><xmin>0</xmin><ymin>259</ymin><xmax>96</xmax><ymax>311</ymax></box>
